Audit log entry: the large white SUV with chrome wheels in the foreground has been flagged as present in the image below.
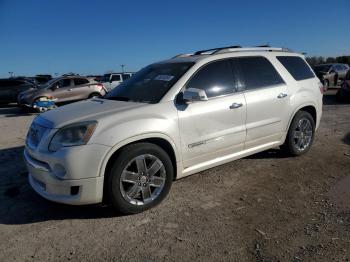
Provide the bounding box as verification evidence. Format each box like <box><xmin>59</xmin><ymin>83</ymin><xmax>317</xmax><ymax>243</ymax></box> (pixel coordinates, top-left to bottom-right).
<box><xmin>24</xmin><ymin>47</ymin><xmax>323</xmax><ymax>213</ymax></box>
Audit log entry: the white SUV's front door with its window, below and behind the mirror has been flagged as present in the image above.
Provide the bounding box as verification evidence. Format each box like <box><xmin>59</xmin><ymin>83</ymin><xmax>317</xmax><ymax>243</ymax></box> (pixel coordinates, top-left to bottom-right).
<box><xmin>178</xmin><ymin>59</ymin><xmax>246</xmax><ymax>168</ymax></box>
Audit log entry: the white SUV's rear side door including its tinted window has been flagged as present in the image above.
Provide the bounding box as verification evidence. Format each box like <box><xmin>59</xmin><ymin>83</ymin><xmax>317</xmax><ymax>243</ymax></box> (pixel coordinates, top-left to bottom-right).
<box><xmin>237</xmin><ymin>56</ymin><xmax>289</xmax><ymax>149</ymax></box>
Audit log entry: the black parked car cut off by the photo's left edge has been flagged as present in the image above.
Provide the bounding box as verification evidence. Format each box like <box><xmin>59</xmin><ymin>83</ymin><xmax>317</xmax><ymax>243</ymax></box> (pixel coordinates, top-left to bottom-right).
<box><xmin>0</xmin><ymin>78</ymin><xmax>36</xmax><ymax>104</ymax></box>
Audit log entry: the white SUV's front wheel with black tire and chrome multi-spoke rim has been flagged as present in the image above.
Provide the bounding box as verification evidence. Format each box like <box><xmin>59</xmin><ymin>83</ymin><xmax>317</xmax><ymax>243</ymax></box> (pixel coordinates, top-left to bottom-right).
<box><xmin>106</xmin><ymin>143</ymin><xmax>174</xmax><ymax>214</ymax></box>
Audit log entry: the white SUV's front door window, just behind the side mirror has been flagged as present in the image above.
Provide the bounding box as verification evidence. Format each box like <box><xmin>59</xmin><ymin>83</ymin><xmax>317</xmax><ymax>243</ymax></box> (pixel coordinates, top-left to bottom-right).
<box><xmin>186</xmin><ymin>60</ymin><xmax>234</xmax><ymax>98</ymax></box>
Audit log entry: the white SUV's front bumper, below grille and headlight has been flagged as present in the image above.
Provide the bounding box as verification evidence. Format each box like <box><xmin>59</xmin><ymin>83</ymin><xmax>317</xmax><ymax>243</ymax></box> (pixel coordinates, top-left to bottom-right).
<box><xmin>24</xmin><ymin>143</ymin><xmax>108</xmax><ymax>205</ymax></box>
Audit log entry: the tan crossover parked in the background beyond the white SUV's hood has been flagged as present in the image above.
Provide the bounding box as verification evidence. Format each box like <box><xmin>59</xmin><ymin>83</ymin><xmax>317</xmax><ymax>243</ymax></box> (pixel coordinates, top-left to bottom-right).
<box><xmin>18</xmin><ymin>76</ymin><xmax>106</xmax><ymax>107</ymax></box>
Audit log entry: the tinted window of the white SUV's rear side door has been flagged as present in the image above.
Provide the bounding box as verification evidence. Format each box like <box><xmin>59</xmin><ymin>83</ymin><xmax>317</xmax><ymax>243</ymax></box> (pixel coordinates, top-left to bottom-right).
<box><xmin>237</xmin><ymin>57</ymin><xmax>284</xmax><ymax>90</ymax></box>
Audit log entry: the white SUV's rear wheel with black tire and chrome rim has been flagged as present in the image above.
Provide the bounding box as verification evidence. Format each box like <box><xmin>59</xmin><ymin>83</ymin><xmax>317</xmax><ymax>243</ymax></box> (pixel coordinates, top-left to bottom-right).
<box><xmin>282</xmin><ymin>111</ymin><xmax>315</xmax><ymax>156</ymax></box>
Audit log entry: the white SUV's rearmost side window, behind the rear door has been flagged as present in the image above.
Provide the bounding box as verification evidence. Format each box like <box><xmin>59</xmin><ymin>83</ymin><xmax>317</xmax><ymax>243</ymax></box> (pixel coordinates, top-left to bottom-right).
<box><xmin>277</xmin><ymin>56</ymin><xmax>315</xmax><ymax>81</ymax></box>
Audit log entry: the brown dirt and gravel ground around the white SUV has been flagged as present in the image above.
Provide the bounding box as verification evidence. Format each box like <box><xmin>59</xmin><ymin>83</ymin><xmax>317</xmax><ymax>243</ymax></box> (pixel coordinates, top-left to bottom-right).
<box><xmin>0</xmin><ymin>91</ymin><xmax>350</xmax><ymax>261</ymax></box>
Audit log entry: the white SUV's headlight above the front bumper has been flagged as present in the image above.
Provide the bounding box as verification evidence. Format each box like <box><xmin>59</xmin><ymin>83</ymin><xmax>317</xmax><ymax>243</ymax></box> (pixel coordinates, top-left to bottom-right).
<box><xmin>49</xmin><ymin>121</ymin><xmax>97</xmax><ymax>151</ymax></box>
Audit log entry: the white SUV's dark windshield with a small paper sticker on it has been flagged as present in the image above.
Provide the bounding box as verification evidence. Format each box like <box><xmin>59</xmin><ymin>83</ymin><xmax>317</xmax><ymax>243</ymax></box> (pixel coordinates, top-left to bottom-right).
<box><xmin>104</xmin><ymin>62</ymin><xmax>194</xmax><ymax>104</ymax></box>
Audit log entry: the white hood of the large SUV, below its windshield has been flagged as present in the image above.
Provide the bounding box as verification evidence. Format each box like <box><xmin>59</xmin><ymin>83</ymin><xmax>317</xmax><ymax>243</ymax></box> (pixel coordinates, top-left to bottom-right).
<box><xmin>39</xmin><ymin>98</ymin><xmax>148</xmax><ymax>128</ymax></box>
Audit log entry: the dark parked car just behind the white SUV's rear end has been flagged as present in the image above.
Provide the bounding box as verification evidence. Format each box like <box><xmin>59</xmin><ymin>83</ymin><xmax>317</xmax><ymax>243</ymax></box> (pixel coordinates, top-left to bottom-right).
<box><xmin>313</xmin><ymin>64</ymin><xmax>349</xmax><ymax>90</ymax></box>
